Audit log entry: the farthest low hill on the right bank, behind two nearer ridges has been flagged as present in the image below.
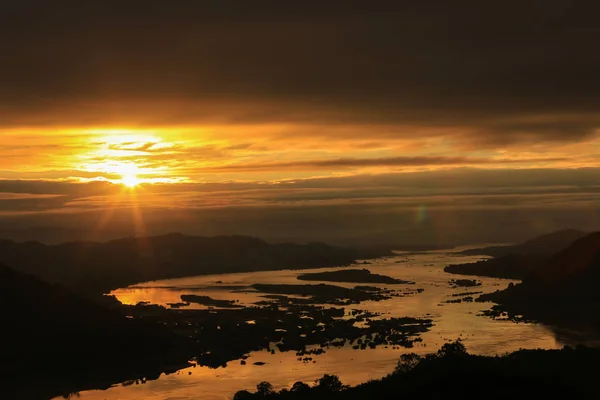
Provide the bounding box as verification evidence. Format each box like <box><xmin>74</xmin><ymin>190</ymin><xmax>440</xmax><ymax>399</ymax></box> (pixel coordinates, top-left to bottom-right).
<box><xmin>461</xmin><ymin>229</ymin><xmax>587</xmax><ymax>257</ymax></box>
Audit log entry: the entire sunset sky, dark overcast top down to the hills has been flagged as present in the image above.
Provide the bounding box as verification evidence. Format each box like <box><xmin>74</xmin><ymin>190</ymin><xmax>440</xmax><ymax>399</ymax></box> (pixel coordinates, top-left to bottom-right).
<box><xmin>0</xmin><ymin>0</ymin><xmax>600</xmax><ymax>244</ymax></box>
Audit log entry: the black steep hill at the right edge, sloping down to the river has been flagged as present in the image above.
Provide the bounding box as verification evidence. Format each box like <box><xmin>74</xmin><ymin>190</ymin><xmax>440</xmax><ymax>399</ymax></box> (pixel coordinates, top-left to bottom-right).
<box><xmin>479</xmin><ymin>232</ymin><xmax>600</xmax><ymax>332</ymax></box>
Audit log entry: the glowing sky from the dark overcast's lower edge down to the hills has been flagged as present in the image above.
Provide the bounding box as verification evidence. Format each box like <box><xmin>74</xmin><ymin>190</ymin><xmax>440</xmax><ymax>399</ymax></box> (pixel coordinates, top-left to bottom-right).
<box><xmin>0</xmin><ymin>124</ymin><xmax>600</xmax><ymax>243</ymax></box>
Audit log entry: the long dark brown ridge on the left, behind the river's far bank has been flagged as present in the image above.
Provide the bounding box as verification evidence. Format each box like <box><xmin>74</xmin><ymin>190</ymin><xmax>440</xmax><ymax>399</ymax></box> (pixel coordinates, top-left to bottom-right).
<box><xmin>0</xmin><ymin>234</ymin><xmax>393</xmax><ymax>294</ymax></box>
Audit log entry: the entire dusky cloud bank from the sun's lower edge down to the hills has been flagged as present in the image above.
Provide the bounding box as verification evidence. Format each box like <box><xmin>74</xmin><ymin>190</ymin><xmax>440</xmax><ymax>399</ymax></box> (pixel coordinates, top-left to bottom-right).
<box><xmin>0</xmin><ymin>168</ymin><xmax>600</xmax><ymax>244</ymax></box>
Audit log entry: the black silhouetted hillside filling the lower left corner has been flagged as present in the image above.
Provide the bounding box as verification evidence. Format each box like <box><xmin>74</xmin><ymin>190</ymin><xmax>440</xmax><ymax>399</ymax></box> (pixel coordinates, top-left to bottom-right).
<box><xmin>0</xmin><ymin>264</ymin><xmax>188</xmax><ymax>400</ymax></box>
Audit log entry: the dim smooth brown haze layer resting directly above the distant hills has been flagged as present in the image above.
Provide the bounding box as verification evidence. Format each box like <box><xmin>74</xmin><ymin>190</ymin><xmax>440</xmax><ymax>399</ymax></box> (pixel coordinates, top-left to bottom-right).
<box><xmin>0</xmin><ymin>192</ymin><xmax>600</xmax><ymax>244</ymax></box>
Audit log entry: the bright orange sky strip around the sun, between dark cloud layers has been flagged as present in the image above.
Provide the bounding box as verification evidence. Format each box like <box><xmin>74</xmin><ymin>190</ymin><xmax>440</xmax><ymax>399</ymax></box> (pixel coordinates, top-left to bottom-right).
<box><xmin>0</xmin><ymin>125</ymin><xmax>600</xmax><ymax>184</ymax></box>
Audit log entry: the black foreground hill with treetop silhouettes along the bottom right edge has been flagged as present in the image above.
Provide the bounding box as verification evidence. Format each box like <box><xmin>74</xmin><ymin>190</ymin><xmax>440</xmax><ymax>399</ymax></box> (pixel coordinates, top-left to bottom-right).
<box><xmin>234</xmin><ymin>342</ymin><xmax>600</xmax><ymax>400</ymax></box>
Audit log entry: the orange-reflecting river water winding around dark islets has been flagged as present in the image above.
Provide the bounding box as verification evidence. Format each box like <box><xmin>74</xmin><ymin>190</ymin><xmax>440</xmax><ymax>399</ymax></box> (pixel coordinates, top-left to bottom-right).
<box><xmin>59</xmin><ymin>249</ymin><xmax>566</xmax><ymax>400</ymax></box>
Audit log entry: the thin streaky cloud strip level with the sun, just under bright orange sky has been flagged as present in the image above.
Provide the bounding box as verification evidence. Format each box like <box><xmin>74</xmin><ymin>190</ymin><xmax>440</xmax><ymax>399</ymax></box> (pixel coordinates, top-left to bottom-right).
<box><xmin>0</xmin><ymin>168</ymin><xmax>600</xmax><ymax>197</ymax></box>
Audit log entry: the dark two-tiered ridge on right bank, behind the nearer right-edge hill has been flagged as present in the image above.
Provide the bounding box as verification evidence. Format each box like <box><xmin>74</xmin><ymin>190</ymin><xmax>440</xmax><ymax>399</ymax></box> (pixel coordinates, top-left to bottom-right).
<box><xmin>444</xmin><ymin>229</ymin><xmax>587</xmax><ymax>279</ymax></box>
